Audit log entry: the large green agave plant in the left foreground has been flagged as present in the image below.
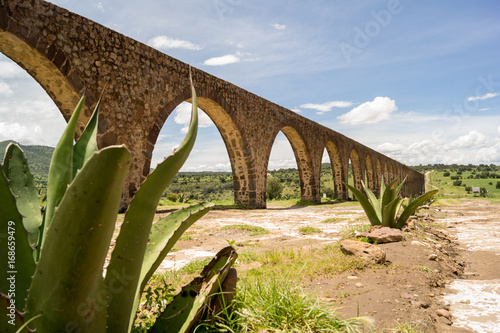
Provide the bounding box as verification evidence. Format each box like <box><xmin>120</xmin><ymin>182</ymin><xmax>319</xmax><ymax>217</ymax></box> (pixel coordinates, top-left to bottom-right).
<box><xmin>0</xmin><ymin>76</ymin><xmax>237</xmax><ymax>333</ymax></box>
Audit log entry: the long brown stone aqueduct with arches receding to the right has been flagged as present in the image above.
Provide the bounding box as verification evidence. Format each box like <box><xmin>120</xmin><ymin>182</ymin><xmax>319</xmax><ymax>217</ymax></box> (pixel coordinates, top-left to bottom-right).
<box><xmin>0</xmin><ymin>0</ymin><xmax>424</xmax><ymax>208</ymax></box>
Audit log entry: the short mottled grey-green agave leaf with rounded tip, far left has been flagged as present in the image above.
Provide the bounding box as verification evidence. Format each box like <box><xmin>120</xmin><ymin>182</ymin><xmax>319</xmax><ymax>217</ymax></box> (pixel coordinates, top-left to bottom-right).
<box><xmin>3</xmin><ymin>143</ymin><xmax>42</xmax><ymax>248</ymax></box>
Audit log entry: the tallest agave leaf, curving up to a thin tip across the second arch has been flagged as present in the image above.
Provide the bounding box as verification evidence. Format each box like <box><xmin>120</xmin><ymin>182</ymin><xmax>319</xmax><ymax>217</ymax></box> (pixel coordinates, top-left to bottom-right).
<box><xmin>105</xmin><ymin>76</ymin><xmax>198</xmax><ymax>333</ymax></box>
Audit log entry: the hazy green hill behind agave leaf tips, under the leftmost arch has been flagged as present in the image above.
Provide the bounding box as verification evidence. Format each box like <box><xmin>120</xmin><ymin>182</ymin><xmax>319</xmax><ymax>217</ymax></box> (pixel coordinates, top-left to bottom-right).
<box><xmin>0</xmin><ymin>140</ymin><xmax>54</xmax><ymax>180</ymax></box>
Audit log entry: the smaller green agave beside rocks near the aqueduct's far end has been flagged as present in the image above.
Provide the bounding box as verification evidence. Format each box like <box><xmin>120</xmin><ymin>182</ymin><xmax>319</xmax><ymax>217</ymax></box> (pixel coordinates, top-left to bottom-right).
<box><xmin>344</xmin><ymin>178</ymin><xmax>438</xmax><ymax>229</ymax></box>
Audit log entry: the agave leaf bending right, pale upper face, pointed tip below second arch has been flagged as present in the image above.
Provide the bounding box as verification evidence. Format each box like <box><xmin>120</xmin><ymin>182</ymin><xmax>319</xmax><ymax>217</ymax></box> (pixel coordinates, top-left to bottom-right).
<box><xmin>136</xmin><ymin>202</ymin><xmax>214</xmax><ymax>306</ymax></box>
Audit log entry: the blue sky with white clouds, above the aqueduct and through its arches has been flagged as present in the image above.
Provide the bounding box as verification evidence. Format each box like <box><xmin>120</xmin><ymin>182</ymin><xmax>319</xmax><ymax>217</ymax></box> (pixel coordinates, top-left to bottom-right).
<box><xmin>0</xmin><ymin>0</ymin><xmax>500</xmax><ymax>171</ymax></box>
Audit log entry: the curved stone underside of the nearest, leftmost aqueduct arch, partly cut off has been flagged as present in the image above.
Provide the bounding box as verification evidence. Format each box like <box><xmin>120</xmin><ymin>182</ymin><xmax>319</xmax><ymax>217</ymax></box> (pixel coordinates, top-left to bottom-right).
<box><xmin>0</xmin><ymin>26</ymin><xmax>89</xmax><ymax>135</ymax></box>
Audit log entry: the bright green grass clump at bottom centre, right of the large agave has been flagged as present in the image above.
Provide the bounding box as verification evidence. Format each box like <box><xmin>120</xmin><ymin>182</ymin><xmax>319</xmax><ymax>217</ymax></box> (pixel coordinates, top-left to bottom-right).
<box><xmin>195</xmin><ymin>276</ymin><xmax>370</xmax><ymax>333</ymax></box>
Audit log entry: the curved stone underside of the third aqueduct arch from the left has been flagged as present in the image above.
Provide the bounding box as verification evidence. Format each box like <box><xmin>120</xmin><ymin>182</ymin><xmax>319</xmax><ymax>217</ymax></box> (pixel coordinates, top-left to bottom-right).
<box><xmin>266</xmin><ymin>126</ymin><xmax>314</xmax><ymax>202</ymax></box>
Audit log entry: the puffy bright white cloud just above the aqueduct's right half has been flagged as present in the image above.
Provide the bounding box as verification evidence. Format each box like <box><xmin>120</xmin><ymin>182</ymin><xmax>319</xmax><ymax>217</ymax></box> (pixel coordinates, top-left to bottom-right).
<box><xmin>337</xmin><ymin>97</ymin><xmax>398</xmax><ymax>125</ymax></box>
